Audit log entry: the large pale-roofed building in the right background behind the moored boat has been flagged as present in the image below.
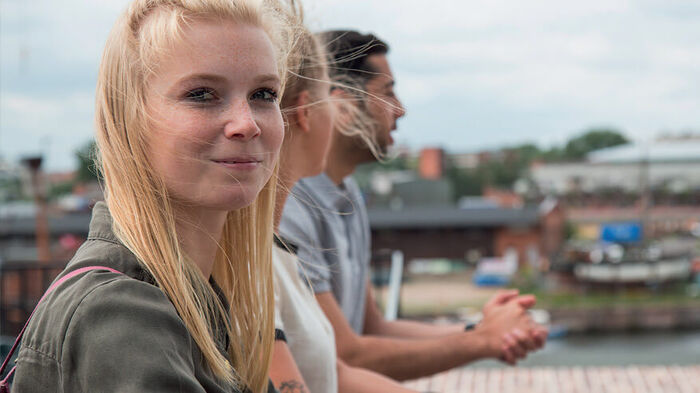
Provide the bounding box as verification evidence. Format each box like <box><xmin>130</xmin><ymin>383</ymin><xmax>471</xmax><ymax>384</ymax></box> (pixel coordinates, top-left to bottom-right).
<box><xmin>530</xmin><ymin>138</ymin><xmax>700</xmax><ymax>240</ymax></box>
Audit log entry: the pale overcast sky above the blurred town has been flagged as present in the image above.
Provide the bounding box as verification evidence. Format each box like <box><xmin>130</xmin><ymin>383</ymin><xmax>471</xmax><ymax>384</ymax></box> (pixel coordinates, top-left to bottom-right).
<box><xmin>0</xmin><ymin>0</ymin><xmax>700</xmax><ymax>170</ymax></box>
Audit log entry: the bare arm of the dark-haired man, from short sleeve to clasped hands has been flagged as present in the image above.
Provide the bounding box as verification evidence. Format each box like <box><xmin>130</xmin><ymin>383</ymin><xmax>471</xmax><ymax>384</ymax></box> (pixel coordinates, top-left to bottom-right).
<box><xmin>316</xmin><ymin>292</ymin><xmax>529</xmax><ymax>380</ymax></box>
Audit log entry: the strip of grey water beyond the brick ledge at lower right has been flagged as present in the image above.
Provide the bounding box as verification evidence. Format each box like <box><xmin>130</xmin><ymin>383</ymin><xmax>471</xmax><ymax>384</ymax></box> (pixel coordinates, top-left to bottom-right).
<box><xmin>473</xmin><ymin>331</ymin><xmax>700</xmax><ymax>367</ymax></box>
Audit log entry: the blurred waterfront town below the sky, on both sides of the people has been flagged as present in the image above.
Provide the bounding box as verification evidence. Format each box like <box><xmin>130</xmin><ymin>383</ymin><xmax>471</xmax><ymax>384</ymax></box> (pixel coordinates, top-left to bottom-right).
<box><xmin>0</xmin><ymin>129</ymin><xmax>700</xmax><ymax>366</ymax></box>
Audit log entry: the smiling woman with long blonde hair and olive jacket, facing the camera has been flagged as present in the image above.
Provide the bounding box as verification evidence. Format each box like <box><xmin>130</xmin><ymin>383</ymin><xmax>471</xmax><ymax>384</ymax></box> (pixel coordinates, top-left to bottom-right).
<box><xmin>13</xmin><ymin>0</ymin><xmax>292</xmax><ymax>393</ymax></box>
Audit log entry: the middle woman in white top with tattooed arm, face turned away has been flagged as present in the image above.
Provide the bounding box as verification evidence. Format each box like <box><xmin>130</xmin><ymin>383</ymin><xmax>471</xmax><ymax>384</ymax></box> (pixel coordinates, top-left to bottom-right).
<box><xmin>270</xmin><ymin>11</ymin><xmax>422</xmax><ymax>393</ymax></box>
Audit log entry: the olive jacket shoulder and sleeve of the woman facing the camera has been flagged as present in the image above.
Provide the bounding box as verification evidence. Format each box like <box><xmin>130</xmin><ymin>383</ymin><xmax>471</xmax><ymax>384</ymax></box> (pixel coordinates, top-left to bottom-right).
<box><xmin>15</xmin><ymin>264</ymin><xmax>207</xmax><ymax>392</ymax></box>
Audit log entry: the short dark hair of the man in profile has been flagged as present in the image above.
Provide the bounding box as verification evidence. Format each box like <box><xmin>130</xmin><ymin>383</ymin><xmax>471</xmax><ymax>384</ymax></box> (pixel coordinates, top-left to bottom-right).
<box><xmin>319</xmin><ymin>30</ymin><xmax>389</xmax><ymax>86</ymax></box>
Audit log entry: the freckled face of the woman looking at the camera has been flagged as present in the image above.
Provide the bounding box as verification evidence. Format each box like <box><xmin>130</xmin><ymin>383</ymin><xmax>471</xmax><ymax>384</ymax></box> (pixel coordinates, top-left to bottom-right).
<box><xmin>146</xmin><ymin>19</ymin><xmax>283</xmax><ymax>210</ymax></box>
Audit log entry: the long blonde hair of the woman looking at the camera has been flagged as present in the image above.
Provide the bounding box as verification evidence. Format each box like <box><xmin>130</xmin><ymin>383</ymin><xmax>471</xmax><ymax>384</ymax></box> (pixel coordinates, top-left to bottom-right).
<box><xmin>95</xmin><ymin>0</ymin><xmax>294</xmax><ymax>392</ymax></box>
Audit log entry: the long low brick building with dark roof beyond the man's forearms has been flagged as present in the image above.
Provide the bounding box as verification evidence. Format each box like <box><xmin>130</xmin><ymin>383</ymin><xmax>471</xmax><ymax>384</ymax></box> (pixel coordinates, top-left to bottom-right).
<box><xmin>369</xmin><ymin>200</ymin><xmax>564</xmax><ymax>264</ymax></box>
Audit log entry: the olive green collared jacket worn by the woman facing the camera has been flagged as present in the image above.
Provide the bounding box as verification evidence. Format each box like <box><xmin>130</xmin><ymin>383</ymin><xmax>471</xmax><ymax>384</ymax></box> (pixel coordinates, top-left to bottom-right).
<box><xmin>12</xmin><ymin>203</ymin><xmax>274</xmax><ymax>393</ymax></box>
